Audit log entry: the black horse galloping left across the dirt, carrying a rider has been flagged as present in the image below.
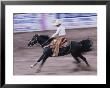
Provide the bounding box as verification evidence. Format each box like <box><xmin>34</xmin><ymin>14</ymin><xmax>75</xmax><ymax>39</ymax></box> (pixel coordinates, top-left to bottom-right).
<box><xmin>28</xmin><ymin>34</ymin><xmax>93</xmax><ymax>72</ymax></box>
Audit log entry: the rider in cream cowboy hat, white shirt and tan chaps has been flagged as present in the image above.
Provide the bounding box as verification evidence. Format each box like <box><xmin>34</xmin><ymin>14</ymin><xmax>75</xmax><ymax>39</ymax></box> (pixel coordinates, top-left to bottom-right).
<box><xmin>51</xmin><ymin>19</ymin><xmax>67</xmax><ymax>56</ymax></box>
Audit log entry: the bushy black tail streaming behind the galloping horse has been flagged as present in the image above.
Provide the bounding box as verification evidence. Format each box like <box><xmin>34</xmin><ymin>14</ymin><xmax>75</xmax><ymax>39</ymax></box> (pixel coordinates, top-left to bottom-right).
<box><xmin>79</xmin><ymin>38</ymin><xmax>93</xmax><ymax>52</ymax></box>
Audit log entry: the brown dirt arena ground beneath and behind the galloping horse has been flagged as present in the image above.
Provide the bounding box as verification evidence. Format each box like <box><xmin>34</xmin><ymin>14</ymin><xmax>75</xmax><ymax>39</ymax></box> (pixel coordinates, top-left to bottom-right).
<box><xmin>13</xmin><ymin>28</ymin><xmax>97</xmax><ymax>75</ymax></box>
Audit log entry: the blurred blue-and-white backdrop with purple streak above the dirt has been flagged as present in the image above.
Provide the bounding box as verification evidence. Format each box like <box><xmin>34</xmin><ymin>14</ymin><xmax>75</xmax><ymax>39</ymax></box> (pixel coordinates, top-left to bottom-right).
<box><xmin>13</xmin><ymin>13</ymin><xmax>97</xmax><ymax>32</ymax></box>
